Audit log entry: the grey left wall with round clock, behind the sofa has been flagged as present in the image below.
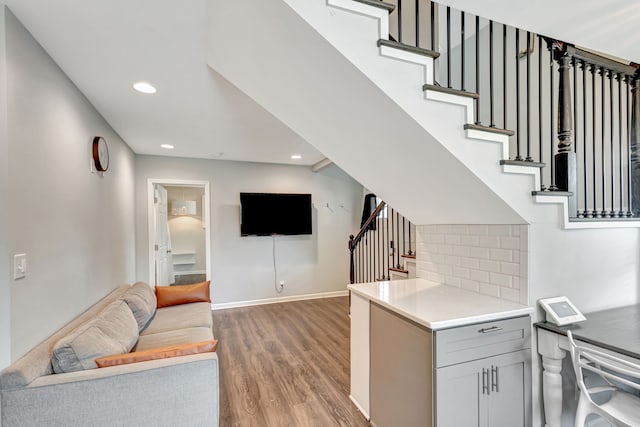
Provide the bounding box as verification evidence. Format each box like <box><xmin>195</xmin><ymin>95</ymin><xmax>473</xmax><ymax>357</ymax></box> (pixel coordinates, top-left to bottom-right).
<box><xmin>1</xmin><ymin>8</ymin><xmax>135</xmax><ymax>359</ymax></box>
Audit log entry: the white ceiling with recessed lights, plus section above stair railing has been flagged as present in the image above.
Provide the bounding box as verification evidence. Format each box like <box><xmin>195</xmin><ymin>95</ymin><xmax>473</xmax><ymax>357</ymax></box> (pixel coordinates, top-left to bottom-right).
<box><xmin>5</xmin><ymin>0</ymin><xmax>640</xmax><ymax>165</ymax></box>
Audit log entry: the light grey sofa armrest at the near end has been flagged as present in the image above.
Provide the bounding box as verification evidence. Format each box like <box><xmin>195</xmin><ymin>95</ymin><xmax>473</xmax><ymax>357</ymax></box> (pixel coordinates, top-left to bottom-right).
<box><xmin>1</xmin><ymin>353</ymin><xmax>219</xmax><ymax>426</ymax></box>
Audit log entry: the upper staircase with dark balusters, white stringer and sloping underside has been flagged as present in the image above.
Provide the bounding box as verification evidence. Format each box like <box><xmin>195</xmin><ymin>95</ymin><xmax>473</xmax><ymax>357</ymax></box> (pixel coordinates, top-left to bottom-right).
<box><xmin>209</xmin><ymin>0</ymin><xmax>638</xmax><ymax>228</ymax></box>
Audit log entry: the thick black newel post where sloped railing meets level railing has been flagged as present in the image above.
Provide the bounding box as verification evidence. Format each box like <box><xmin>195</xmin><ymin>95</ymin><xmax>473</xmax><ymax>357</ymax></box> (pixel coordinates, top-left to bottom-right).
<box><xmin>554</xmin><ymin>41</ymin><xmax>578</xmax><ymax>216</ymax></box>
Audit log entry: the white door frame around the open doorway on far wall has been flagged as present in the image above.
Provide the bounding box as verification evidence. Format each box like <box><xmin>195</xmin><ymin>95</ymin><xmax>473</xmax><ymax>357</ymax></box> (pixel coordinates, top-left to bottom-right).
<box><xmin>147</xmin><ymin>178</ymin><xmax>211</xmax><ymax>285</ymax></box>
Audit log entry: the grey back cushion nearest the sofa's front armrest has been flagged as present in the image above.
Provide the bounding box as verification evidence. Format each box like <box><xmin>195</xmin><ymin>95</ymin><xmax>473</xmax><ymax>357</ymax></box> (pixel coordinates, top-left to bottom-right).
<box><xmin>51</xmin><ymin>300</ymin><xmax>138</xmax><ymax>373</ymax></box>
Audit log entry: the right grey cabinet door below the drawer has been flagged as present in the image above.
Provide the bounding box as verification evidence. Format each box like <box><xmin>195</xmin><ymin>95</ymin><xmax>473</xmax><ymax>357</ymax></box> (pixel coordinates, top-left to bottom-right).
<box><xmin>485</xmin><ymin>350</ymin><xmax>531</xmax><ymax>427</ymax></box>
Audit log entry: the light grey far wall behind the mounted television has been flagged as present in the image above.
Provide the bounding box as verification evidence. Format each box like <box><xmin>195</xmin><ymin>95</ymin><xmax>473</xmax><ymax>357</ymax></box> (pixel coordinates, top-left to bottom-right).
<box><xmin>136</xmin><ymin>156</ymin><xmax>362</xmax><ymax>303</ymax></box>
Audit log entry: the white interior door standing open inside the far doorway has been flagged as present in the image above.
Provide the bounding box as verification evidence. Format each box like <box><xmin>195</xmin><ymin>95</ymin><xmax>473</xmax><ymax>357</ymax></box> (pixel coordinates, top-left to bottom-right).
<box><xmin>154</xmin><ymin>184</ymin><xmax>174</xmax><ymax>286</ymax></box>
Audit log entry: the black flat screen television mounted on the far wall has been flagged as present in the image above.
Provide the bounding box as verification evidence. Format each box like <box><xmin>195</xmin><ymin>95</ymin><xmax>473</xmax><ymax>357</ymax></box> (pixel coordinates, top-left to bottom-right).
<box><xmin>240</xmin><ymin>193</ymin><xmax>312</xmax><ymax>236</ymax></box>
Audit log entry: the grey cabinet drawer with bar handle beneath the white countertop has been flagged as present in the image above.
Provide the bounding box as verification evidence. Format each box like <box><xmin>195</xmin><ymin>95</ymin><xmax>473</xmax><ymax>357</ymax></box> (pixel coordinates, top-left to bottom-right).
<box><xmin>434</xmin><ymin>316</ymin><xmax>531</xmax><ymax>368</ymax></box>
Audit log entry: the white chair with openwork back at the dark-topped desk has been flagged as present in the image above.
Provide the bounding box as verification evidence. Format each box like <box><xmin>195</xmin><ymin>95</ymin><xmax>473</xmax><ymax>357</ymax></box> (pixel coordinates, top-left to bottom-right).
<box><xmin>567</xmin><ymin>331</ymin><xmax>640</xmax><ymax>427</ymax></box>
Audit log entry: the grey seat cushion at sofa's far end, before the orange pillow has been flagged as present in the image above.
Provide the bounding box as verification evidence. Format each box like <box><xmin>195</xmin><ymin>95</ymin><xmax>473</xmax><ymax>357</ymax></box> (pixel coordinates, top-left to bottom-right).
<box><xmin>140</xmin><ymin>302</ymin><xmax>212</xmax><ymax>335</ymax></box>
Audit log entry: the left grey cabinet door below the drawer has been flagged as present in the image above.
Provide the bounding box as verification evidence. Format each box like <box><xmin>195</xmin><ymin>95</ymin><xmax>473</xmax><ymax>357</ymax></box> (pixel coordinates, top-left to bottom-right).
<box><xmin>436</xmin><ymin>359</ymin><xmax>494</xmax><ymax>427</ymax></box>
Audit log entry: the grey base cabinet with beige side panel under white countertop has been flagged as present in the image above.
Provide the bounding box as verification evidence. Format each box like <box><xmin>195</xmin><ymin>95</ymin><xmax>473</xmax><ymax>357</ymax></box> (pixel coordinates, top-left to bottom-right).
<box><xmin>351</xmin><ymin>298</ymin><xmax>531</xmax><ymax>427</ymax></box>
